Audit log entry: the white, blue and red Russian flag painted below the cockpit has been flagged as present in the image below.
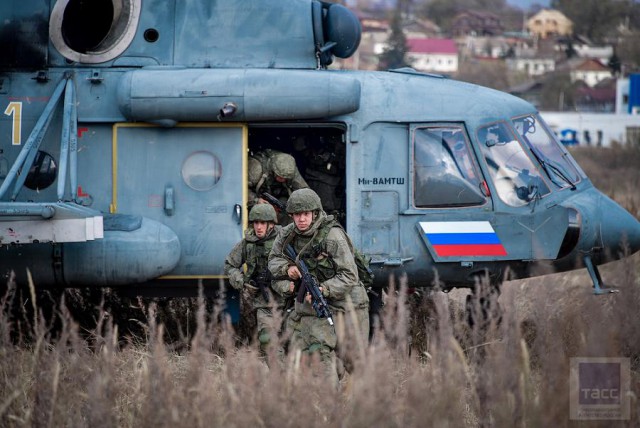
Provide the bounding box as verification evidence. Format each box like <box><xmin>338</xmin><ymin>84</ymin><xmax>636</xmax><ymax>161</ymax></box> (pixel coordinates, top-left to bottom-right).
<box><xmin>420</xmin><ymin>221</ymin><xmax>507</xmax><ymax>257</ymax></box>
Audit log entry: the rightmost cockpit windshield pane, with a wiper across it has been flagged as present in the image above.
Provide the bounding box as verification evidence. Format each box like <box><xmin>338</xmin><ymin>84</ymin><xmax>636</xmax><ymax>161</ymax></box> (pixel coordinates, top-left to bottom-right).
<box><xmin>513</xmin><ymin>115</ymin><xmax>580</xmax><ymax>189</ymax></box>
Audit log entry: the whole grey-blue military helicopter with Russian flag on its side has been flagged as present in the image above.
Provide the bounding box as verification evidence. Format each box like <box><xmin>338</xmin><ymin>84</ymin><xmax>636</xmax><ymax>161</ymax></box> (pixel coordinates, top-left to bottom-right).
<box><xmin>0</xmin><ymin>0</ymin><xmax>640</xmax><ymax>306</ymax></box>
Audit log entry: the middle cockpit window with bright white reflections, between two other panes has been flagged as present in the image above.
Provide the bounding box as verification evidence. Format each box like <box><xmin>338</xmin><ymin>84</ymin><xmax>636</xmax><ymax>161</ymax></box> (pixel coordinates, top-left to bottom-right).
<box><xmin>478</xmin><ymin>122</ymin><xmax>549</xmax><ymax>207</ymax></box>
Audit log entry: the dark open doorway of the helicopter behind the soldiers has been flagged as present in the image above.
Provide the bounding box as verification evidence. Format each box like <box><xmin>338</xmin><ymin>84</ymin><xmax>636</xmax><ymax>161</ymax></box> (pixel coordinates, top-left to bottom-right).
<box><xmin>249</xmin><ymin>124</ymin><xmax>346</xmax><ymax>227</ymax></box>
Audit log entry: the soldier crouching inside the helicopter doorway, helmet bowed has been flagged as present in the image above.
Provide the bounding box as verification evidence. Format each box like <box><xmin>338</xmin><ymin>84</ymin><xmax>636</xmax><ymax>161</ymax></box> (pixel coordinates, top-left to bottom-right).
<box><xmin>248</xmin><ymin>149</ymin><xmax>309</xmax><ymax>224</ymax></box>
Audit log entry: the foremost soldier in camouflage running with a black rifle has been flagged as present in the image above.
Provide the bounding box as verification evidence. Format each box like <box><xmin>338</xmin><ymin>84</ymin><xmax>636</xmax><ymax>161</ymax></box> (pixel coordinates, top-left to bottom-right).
<box><xmin>269</xmin><ymin>189</ymin><xmax>369</xmax><ymax>385</ymax></box>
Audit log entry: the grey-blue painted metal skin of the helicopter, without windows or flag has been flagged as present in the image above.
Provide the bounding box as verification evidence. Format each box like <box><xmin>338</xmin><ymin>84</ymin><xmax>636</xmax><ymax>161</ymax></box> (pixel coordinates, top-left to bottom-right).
<box><xmin>0</xmin><ymin>0</ymin><xmax>640</xmax><ymax>294</ymax></box>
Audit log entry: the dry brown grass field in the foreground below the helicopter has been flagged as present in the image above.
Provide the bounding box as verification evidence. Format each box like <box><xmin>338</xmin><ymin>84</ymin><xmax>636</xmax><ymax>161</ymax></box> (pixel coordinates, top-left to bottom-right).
<box><xmin>0</xmin><ymin>145</ymin><xmax>640</xmax><ymax>427</ymax></box>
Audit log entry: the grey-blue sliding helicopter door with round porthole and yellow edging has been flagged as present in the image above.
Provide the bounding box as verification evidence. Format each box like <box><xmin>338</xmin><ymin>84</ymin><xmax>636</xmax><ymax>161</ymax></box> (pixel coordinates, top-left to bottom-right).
<box><xmin>111</xmin><ymin>124</ymin><xmax>247</xmax><ymax>278</ymax></box>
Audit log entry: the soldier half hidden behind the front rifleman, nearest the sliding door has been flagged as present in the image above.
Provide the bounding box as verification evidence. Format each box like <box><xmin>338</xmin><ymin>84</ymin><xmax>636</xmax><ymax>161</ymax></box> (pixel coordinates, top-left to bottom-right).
<box><xmin>224</xmin><ymin>204</ymin><xmax>284</xmax><ymax>353</ymax></box>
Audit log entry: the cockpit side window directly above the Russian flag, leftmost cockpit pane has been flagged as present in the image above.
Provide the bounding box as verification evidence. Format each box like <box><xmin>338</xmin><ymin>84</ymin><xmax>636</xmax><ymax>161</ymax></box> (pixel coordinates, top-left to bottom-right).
<box><xmin>413</xmin><ymin>126</ymin><xmax>486</xmax><ymax>208</ymax></box>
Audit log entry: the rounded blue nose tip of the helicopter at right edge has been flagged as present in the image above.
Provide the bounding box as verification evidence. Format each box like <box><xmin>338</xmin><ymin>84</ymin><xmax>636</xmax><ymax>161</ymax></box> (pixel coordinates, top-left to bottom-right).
<box><xmin>598</xmin><ymin>194</ymin><xmax>640</xmax><ymax>259</ymax></box>
